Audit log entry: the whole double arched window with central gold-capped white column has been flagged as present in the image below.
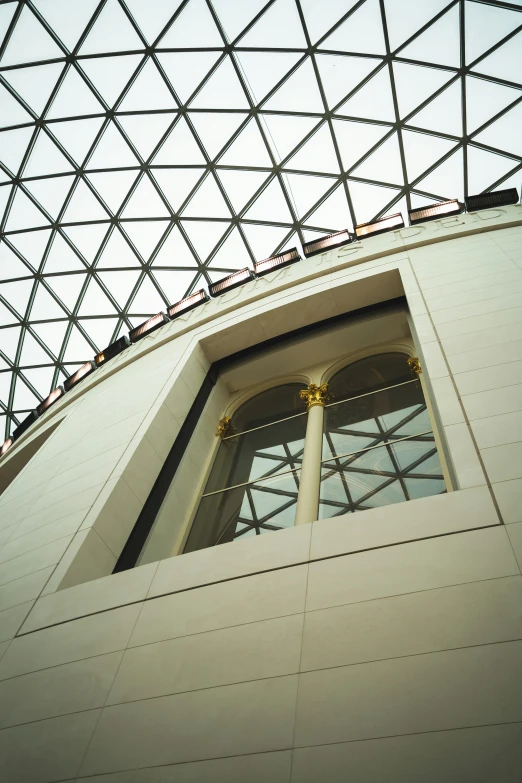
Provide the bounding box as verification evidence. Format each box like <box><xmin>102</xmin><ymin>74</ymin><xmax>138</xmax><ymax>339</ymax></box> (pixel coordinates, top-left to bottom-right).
<box><xmin>185</xmin><ymin>353</ymin><xmax>446</xmax><ymax>552</ymax></box>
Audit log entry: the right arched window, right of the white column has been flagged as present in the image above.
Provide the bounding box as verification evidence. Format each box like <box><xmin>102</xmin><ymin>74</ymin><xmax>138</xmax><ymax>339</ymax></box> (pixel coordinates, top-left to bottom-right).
<box><xmin>319</xmin><ymin>353</ymin><xmax>445</xmax><ymax>519</ymax></box>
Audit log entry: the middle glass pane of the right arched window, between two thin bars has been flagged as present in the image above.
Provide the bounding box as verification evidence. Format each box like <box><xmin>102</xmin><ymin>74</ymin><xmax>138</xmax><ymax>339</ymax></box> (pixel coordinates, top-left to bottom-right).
<box><xmin>323</xmin><ymin>381</ymin><xmax>431</xmax><ymax>459</ymax></box>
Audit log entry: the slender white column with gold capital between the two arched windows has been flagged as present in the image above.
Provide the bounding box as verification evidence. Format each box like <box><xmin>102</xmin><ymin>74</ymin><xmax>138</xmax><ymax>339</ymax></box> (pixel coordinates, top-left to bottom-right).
<box><xmin>295</xmin><ymin>383</ymin><xmax>328</xmax><ymax>525</ymax></box>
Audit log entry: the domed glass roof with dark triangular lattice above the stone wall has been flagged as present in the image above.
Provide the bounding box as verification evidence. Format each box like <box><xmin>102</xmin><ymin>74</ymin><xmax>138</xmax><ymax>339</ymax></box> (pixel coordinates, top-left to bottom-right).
<box><xmin>0</xmin><ymin>0</ymin><xmax>522</xmax><ymax>440</ymax></box>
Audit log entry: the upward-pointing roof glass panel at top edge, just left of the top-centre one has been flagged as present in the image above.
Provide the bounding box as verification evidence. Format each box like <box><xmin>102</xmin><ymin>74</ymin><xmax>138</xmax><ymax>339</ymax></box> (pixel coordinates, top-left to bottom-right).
<box><xmin>158</xmin><ymin>0</ymin><xmax>223</xmax><ymax>49</ymax></box>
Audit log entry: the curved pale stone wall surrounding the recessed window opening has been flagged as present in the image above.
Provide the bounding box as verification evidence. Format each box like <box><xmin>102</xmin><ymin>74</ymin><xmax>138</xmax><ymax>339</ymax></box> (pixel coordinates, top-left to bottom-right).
<box><xmin>0</xmin><ymin>207</ymin><xmax>522</xmax><ymax>783</ymax></box>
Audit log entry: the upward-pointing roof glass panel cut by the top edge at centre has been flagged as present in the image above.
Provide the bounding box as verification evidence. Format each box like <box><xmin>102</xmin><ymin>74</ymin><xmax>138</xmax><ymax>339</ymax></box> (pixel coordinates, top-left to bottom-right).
<box><xmin>239</xmin><ymin>0</ymin><xmax>307</xmax><ymax>49</ymax></box>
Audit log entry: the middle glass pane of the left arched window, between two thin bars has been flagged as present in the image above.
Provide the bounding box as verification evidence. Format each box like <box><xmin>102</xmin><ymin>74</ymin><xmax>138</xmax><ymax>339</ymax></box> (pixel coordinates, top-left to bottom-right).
<box><xmin>205</xmin><ymin>413</ymin><xmax>306</xmax><ymax>494</ymax></box>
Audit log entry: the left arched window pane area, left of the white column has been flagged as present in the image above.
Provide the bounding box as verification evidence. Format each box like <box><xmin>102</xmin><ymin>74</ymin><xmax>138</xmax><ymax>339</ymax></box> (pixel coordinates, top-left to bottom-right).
<box><xmin>185</xmin><ymin>383</ymin><xmax>307</xmax><ymax>552</ymax></box>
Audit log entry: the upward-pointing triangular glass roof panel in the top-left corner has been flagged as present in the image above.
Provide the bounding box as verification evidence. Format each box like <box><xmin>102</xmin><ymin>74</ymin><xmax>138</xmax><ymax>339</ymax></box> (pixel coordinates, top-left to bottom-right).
<box><xmin>0</xmin><ymin>5</ymin><xmax>63</xmax><ymax>66</ymax></box>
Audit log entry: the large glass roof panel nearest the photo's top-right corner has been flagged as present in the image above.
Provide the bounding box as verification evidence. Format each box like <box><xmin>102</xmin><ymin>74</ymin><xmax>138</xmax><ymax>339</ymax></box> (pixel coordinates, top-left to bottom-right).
<box><xmin>465</xmin><ymin>0</ymin><xmax>522</xmax><ymax>65</ymax></box>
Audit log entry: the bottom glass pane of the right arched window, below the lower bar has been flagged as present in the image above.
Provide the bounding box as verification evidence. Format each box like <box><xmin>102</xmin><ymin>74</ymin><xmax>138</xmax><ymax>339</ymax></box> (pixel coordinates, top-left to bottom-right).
<box><xmin>319</xmin><ymin>433</ymin><xmax>445</xmax><ymax>519</ymax></box>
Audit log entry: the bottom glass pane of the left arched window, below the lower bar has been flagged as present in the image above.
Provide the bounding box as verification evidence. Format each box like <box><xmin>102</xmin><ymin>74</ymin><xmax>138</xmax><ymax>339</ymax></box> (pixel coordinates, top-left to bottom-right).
<box><xmin>185</xmin><ymin>470</ymin><xmax>300</xmax><ymax>552</ymax></box>
